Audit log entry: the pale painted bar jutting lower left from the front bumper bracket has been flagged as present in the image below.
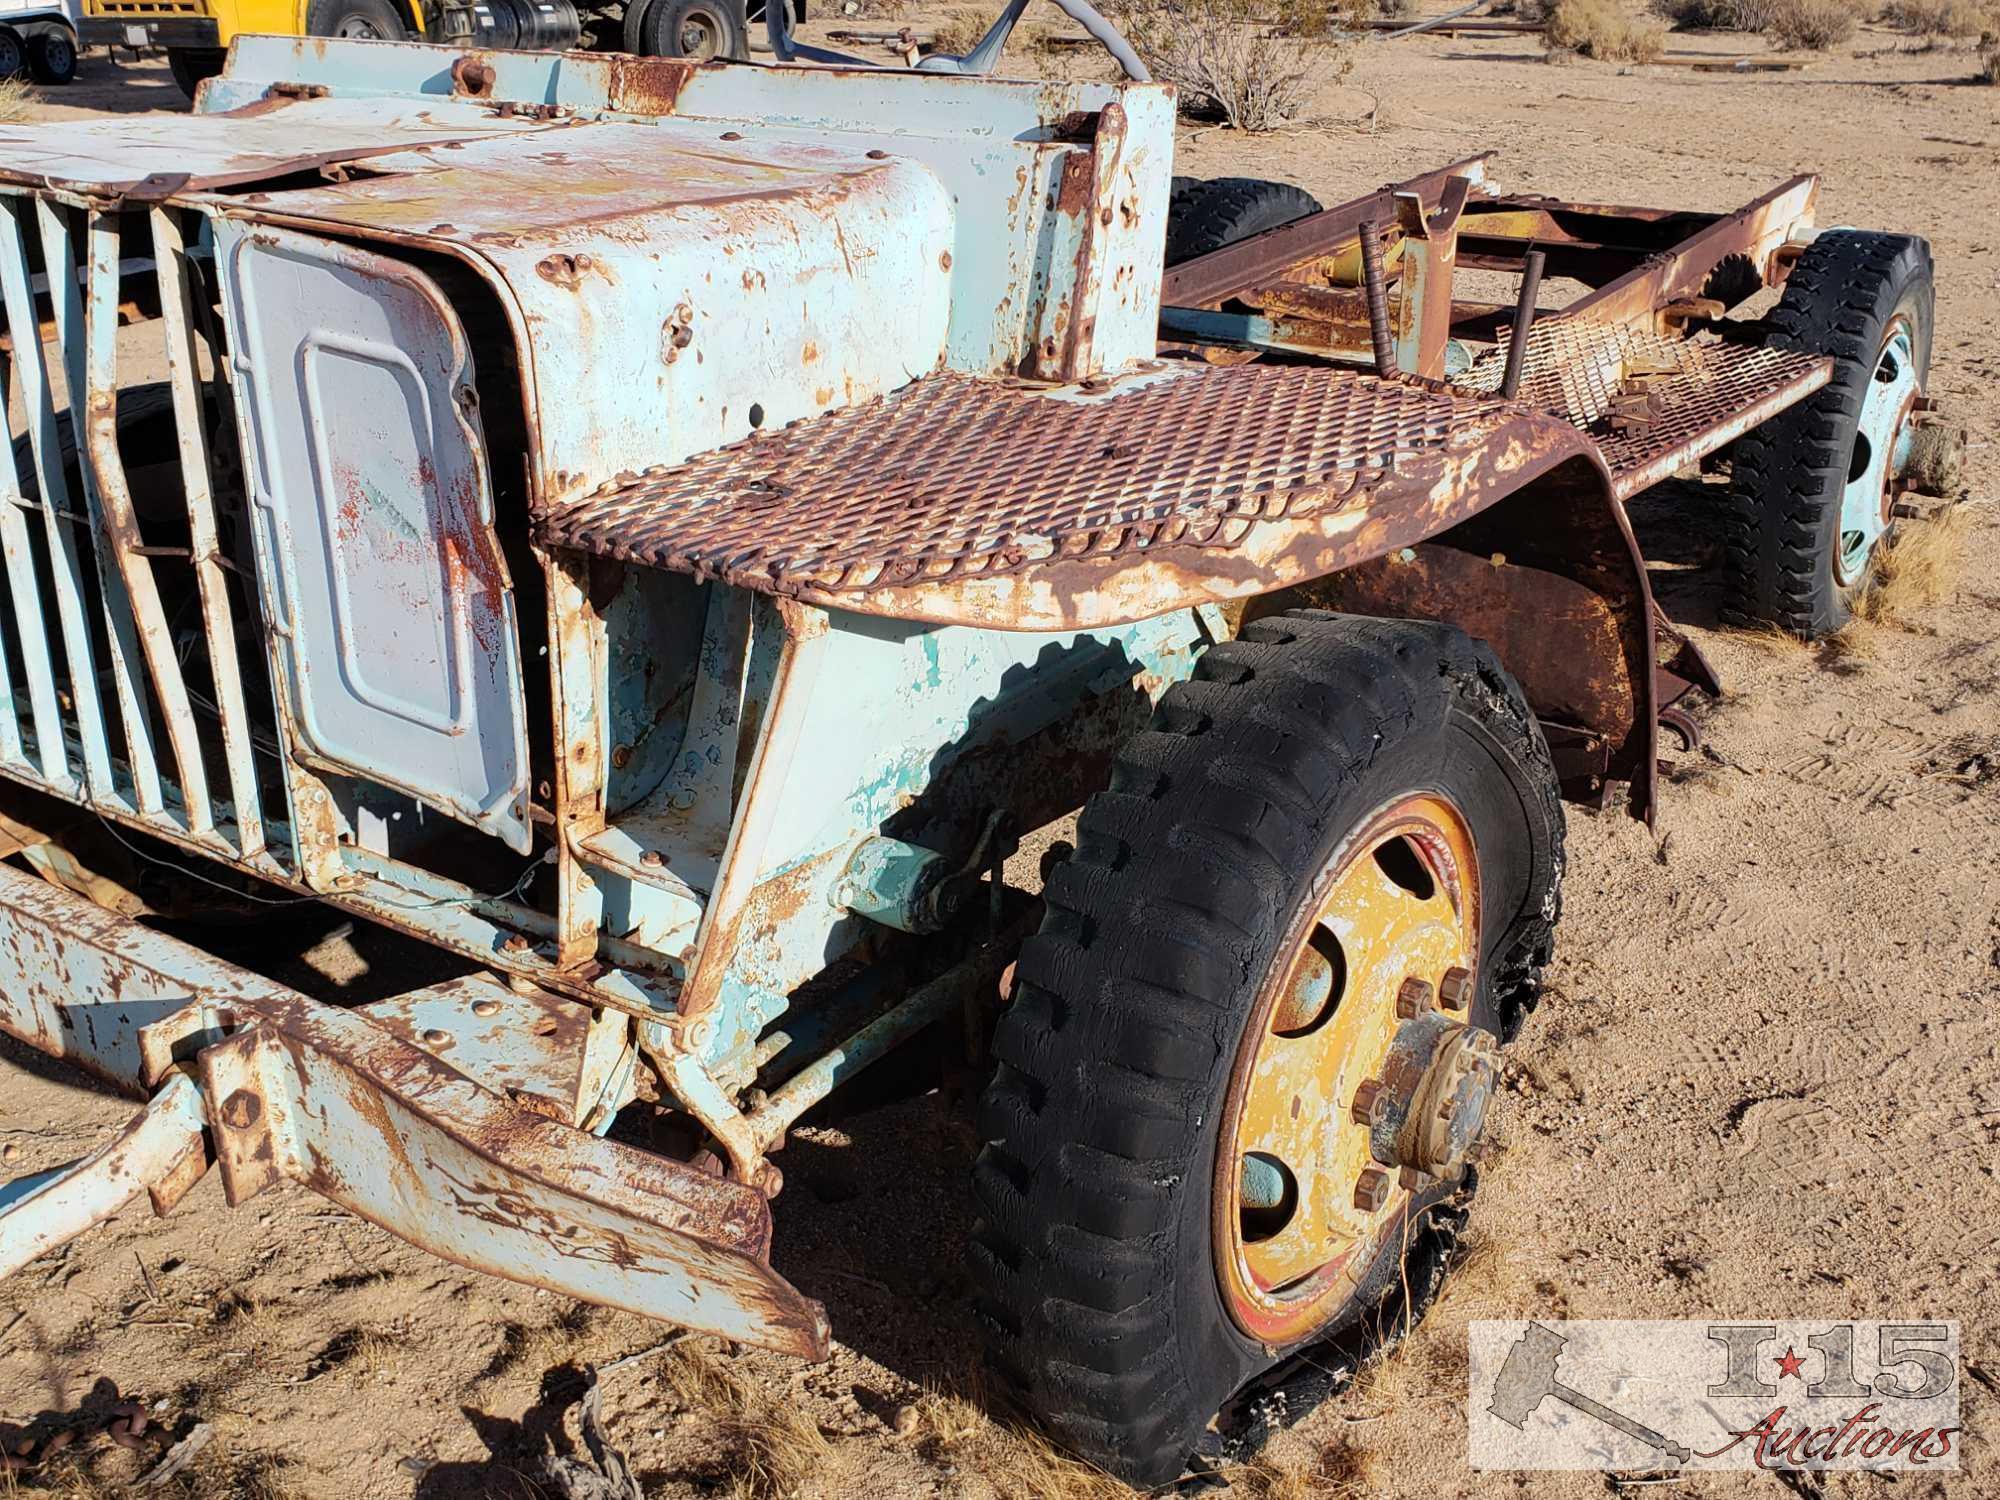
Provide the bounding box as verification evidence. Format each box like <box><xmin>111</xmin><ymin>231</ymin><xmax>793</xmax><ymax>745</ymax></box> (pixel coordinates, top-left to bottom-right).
<box><xmin>0</xmin><ymin>1074</ymin><xmax>204</xmax><ymax>1276</ymax></box>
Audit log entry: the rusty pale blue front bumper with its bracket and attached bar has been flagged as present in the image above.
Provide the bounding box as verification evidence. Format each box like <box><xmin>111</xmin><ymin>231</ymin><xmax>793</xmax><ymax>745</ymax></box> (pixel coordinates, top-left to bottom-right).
<box><xmin>0</xmin><ymin>866</ymin><xmax>826</xmax><ymax>1358</ymax></box>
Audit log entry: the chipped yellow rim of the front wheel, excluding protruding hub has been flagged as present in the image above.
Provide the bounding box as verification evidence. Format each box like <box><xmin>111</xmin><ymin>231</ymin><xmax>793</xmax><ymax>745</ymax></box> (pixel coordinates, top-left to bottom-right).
<box><xmin>1214</xmin><ymin>794</ymin><xmax>1480</xmax><ymax>1346</ymax></box>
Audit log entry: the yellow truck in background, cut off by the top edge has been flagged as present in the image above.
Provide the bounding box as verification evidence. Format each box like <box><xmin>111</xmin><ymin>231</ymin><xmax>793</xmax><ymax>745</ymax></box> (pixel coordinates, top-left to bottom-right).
<box><xmin>80</xmin><ymin>0</ymin><xmax>780</xmax><ymax>98</ymax></box>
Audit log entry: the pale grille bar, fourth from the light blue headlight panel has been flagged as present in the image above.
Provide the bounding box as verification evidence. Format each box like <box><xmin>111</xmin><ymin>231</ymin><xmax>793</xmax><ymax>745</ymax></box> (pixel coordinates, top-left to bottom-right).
<box><xmin>0</xmin><ymin>198</ymin><xmax>124</xmax><ymax>806</ymax></box>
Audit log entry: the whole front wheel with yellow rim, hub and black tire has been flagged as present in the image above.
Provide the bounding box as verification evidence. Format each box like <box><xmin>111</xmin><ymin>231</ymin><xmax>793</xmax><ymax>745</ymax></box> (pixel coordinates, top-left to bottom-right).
<box><xmin>972</xmin><ymin>610</ymin><xmax>1564</xmax><ymax>1486</ymax></box>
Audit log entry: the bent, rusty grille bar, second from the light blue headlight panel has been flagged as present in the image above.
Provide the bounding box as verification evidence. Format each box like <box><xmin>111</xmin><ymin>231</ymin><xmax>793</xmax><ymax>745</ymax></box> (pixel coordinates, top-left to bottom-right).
<box><xmin>83</xmin><ymin>212</ymin><xmax>216</xmax><ymax>836</ymax></box>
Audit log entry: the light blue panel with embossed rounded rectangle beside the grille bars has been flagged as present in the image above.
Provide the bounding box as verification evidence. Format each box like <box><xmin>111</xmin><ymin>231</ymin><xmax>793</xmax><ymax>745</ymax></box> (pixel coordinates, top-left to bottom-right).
<box><xmin>216</xmin><ymin>220</ymin><xmax>530</xmax><ymax>854</ymax></box>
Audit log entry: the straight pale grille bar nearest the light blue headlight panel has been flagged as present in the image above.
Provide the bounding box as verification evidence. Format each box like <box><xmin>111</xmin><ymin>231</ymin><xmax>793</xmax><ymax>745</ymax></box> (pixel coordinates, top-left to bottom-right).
<box><xmin>152</xmin><ymin>208</ymin><xmax>264</xmax><ymax>860</ymax></box>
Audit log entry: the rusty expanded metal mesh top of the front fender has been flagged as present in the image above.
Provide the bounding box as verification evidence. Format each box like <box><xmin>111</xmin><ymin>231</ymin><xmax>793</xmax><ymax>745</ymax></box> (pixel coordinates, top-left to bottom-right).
<box><xmin>540</xmin><ymin>364</ymin><xmax>1508</xmax><ymax>594</ymax></box>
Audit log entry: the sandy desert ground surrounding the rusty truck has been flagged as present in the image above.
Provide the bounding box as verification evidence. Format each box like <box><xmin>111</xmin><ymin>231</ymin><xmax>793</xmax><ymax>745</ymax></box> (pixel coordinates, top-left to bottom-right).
<box><xmin>0</xmin><ymin>8</ymin><xmax>2000</xmax><ymax>1500</ymax></box>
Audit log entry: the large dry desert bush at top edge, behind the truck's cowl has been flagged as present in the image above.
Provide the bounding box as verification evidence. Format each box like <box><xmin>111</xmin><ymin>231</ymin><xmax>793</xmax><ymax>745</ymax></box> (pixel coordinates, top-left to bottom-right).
<box><xmin>1120</xmin><ymin>0</ymin><xmax>1352</xmax><ymax>130</ymax></box>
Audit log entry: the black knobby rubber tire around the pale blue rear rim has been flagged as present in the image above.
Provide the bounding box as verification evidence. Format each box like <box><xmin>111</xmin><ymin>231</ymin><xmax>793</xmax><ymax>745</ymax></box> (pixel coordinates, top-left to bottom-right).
<box><xmin>1722</xmin><ymin>230</ymin><xmax>1932</xmax><ymax>640</ymax></box>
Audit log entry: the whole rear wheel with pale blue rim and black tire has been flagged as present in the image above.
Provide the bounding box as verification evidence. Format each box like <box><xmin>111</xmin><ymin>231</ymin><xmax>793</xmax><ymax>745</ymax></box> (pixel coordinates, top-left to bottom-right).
<box><xmin>1724</xmin><ymin>230</ymin><xmax>1932</xmax><ymax>640</ymax></box>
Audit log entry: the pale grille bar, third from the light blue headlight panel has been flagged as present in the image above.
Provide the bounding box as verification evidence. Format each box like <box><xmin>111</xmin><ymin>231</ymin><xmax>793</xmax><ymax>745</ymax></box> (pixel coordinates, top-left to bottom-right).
<box><xmin>34</xmin><ymin>198</ymin><xmax>164</xmax><ymax>818</ymax></box>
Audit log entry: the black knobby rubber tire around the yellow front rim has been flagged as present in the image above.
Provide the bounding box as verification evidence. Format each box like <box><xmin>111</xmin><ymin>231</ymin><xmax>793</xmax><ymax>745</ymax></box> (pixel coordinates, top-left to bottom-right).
<box><xmin>970</xmin><ymin>610</ymin><xmax>1564</xmax><ymax>1484</ymax></box>
